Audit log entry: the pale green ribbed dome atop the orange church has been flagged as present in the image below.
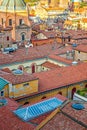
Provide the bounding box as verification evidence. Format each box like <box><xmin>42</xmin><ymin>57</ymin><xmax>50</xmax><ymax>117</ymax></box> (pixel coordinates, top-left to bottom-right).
<box><xmin>0</xmin><ymin>0</ymin><xmax>26</xmax><ymax>12</ymax></box>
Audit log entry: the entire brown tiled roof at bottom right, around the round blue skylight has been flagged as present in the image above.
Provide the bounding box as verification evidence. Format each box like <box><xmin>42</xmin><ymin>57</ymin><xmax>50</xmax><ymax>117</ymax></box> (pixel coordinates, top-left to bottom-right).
<box><xmin>40</xmin><ymin>98</ymin><xmax>87</xmax><ymax>130</ymax></box>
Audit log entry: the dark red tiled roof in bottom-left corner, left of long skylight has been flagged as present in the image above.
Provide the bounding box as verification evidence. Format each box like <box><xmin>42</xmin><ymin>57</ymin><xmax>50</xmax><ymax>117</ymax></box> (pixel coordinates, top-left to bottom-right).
<box><xmin>0</xmin><ymin>99</ymin><xmax>35</xmax><ymax>130</ymax></box>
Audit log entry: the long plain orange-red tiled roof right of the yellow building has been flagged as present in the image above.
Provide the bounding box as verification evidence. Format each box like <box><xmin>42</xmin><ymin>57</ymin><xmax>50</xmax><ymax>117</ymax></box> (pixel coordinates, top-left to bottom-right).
<box><xmin>34</xmin><ymin>63</ymin><xmax>87</xmax><ymax>92</ymax></box>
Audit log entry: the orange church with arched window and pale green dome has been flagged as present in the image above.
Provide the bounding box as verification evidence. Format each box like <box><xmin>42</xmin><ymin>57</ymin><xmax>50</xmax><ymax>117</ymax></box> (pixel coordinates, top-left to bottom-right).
<box><xmin>0</xmin><ymin>0</ymin><xmax>31</xmax><ymax>42</ymax></box>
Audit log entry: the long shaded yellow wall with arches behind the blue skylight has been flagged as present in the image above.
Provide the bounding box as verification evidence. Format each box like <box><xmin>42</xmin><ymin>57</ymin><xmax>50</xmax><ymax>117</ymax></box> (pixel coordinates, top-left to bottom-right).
<box><xmin>18</xmin><ymin>82</ymin><xmax>87</xmax><ymax>105</ymax></box>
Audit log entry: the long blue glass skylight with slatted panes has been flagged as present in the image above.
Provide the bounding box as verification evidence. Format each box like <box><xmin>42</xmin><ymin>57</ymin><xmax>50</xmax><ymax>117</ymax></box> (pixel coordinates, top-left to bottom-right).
<box><xmin>14</xmin><ymin>97</ymin><xmax>63</xmax><ymax>121</ymax></box>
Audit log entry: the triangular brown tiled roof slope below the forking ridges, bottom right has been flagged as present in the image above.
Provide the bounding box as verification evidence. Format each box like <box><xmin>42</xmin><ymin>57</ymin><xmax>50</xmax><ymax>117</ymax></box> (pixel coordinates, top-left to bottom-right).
<box><xmin>40</xmin><ymin>110</ymin><xmax>86</xmax><ymax>130</ymax></box>
